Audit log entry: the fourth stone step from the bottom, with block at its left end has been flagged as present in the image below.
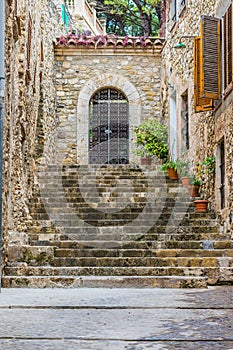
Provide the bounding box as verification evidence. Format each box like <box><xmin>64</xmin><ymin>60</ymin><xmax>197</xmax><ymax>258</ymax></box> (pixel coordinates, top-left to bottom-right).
<box><xmin>8</xmin><ymin>243</ymin><xmax>233</xmax><ymax>264</ymax></box>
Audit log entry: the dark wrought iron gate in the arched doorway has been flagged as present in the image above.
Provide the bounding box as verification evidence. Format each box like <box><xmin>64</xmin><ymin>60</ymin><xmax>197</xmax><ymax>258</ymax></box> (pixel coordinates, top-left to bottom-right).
<box><xmin>89</xmin><ymin>88</ymin><xmax>129</xmax><ymax>164</ymax></box>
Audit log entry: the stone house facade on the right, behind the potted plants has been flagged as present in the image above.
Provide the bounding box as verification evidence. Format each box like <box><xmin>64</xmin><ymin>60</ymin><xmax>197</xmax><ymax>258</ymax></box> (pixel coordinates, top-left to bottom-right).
<box><xmin>162</xmin><ymin>0</ymin><xmax>233</xmax><ymax>235</ymax></box>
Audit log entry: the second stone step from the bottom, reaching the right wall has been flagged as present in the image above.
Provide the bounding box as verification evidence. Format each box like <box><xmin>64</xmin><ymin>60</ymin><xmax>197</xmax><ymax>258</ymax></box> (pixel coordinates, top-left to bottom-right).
<box><xmin>2</xmin><ymin>263</ymin><xmax>233</xmax><ymax>288</ymax></box>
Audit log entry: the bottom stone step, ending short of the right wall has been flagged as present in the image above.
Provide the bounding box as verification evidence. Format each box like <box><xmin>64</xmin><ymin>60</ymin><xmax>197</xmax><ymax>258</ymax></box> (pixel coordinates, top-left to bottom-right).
<box><xmin>2</xmin><ymin>275</ymin><xmax>207</xmax><ymax>288</ymax></box>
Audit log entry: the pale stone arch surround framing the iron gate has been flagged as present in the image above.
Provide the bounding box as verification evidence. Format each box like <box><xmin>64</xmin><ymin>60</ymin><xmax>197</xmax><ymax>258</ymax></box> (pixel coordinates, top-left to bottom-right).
<box><xmin>77</xmin><ymin>74</ymin><xmax>141</xmax><ymax>164</ymax></box>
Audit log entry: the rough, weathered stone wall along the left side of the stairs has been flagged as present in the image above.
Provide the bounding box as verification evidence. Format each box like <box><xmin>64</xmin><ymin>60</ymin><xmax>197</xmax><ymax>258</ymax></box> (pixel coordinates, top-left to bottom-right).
<box><xmin>3</xmin><ymin>0</ymin><xmax>60</xmax><ymax>266</ymax></box>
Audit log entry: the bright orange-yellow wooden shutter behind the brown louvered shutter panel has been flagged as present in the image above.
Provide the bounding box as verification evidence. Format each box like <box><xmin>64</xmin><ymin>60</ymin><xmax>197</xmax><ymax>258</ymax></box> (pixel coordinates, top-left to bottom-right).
<box><xmin>194</xmin><ymin>37</ymin><xmax>213</xmax><ymax>112</ymax></box>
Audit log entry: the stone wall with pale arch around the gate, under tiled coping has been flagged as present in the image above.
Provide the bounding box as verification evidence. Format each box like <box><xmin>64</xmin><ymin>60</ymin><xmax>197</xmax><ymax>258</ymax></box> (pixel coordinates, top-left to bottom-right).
<box><xmin>55</xmin><ymin>41</ymin><xmax>163</xmax><ymax>163</ymax></box>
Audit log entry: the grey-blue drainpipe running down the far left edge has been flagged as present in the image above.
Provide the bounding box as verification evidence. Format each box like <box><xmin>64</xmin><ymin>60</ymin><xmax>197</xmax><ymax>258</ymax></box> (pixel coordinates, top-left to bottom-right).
<box><xmin>0</xmin><ymin>0</ymin><xmax>5</xmax><ymax>292</ymax></box>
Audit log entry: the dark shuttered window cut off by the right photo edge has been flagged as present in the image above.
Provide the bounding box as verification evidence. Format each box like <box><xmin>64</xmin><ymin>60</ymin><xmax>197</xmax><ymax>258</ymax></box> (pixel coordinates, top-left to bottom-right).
<box><xmin>222</xmin><ymin>5</ymin><xmax>233</xmax><ymax>95</ymax></box>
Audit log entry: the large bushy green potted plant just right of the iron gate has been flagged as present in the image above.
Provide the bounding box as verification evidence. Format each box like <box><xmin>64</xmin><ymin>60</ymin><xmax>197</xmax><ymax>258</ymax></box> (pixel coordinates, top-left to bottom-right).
<box><xmin>133</xmin><ymin>118</ymin><xmax>168</xmax><ymax>164</ymax></box>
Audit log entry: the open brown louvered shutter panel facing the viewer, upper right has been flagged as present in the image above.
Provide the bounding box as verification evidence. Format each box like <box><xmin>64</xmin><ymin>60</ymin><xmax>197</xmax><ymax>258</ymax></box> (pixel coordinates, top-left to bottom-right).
<box><xmin>201</xmin><ymin>16</ymin><xmax>221</xmax><ymax>100</ymax></box>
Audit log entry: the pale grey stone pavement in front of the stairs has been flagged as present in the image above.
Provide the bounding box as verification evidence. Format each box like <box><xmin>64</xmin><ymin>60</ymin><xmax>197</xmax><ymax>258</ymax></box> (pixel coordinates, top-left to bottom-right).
<box><xmin>0</xmin><ymin>286</ymin><xmax>233</xmax><ymax>350</ymax></box>
